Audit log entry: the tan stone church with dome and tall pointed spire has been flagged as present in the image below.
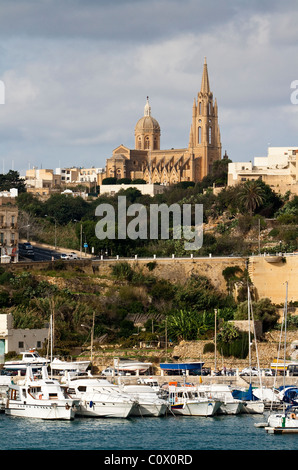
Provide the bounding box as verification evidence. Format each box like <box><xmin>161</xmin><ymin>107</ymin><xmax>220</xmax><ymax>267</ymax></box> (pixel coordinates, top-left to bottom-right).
<box><xmin>98</xmin><ymin>58</ymin><xmax>222</xmax><ymax>186</ymax></box>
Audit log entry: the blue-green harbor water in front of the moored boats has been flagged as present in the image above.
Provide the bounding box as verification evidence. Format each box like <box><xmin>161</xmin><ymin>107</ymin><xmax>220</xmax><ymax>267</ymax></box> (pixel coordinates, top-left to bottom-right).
<box><xmin>0</xmin><ymin>412</ymin><xmax>298</xmax><ymax>451</ymax></box>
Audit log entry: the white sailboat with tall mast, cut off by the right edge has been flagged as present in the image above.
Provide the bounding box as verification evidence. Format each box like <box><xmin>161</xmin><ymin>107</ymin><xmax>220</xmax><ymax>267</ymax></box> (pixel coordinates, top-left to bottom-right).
<box><xmin>265</xmin><ymin>283</ymin><xmax>298</xmax><ymax>434</ymax></box>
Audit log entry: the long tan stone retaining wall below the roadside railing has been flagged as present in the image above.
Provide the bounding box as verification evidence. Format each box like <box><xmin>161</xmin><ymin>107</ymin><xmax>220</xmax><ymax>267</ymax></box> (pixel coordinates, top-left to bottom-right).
<box><xmin>6</xmin><ymin>255</ymin><xmax>298</xmax><ymax>305</ymax></box>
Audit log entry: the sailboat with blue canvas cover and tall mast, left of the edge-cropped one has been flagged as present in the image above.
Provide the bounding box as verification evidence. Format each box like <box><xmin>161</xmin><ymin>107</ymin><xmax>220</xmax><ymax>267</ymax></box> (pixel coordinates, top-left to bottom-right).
<box><xmin>232</xmin><ymin>286</ymin><xmax>265</xmax><ymax>414</ymax></box>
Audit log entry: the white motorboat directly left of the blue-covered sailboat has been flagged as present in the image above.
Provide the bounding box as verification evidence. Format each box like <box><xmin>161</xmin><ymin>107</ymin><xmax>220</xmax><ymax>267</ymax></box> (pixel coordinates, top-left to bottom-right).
<box><xmin>197</xmin><ymin>384</ymin><xmax>244</xmax><ymax>415</ymax></box>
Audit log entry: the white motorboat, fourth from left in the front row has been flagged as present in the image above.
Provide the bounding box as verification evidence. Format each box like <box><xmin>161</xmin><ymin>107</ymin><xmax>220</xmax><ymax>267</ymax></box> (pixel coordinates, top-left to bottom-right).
<box><xmin>168</xmin><ymin>385</ymin><xmax>222</xmax><ymax>417</ymax></box>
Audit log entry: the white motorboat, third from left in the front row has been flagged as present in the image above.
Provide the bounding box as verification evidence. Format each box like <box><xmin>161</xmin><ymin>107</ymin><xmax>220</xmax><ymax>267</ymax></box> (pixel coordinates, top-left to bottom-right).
<box><xmin>121</xmin><ymin>385</ymin><xmax>168</xmax><ymax>416</ymax></box>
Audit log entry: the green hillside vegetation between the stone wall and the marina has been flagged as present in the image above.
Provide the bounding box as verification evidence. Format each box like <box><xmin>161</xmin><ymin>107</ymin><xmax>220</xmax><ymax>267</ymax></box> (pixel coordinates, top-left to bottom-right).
<box><xmin>0</xmin><ymin>261</ymin><xmax>277</xmax><ymax>357</ymax></box>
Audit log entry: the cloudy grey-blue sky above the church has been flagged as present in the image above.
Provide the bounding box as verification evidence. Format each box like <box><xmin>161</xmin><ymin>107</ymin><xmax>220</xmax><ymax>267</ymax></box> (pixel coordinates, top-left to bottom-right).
<box><xmin>0</xmin><ymin>0</ymin><xmax>298</xmax><ymax>175</ymax></box>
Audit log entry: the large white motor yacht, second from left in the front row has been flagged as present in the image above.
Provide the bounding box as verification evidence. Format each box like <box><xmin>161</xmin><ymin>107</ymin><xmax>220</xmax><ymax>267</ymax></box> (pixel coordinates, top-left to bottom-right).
<box><xmin>67</xmin><ymin>376</ymin><xmax>135</xmax><ymax>418</ymax></box>
